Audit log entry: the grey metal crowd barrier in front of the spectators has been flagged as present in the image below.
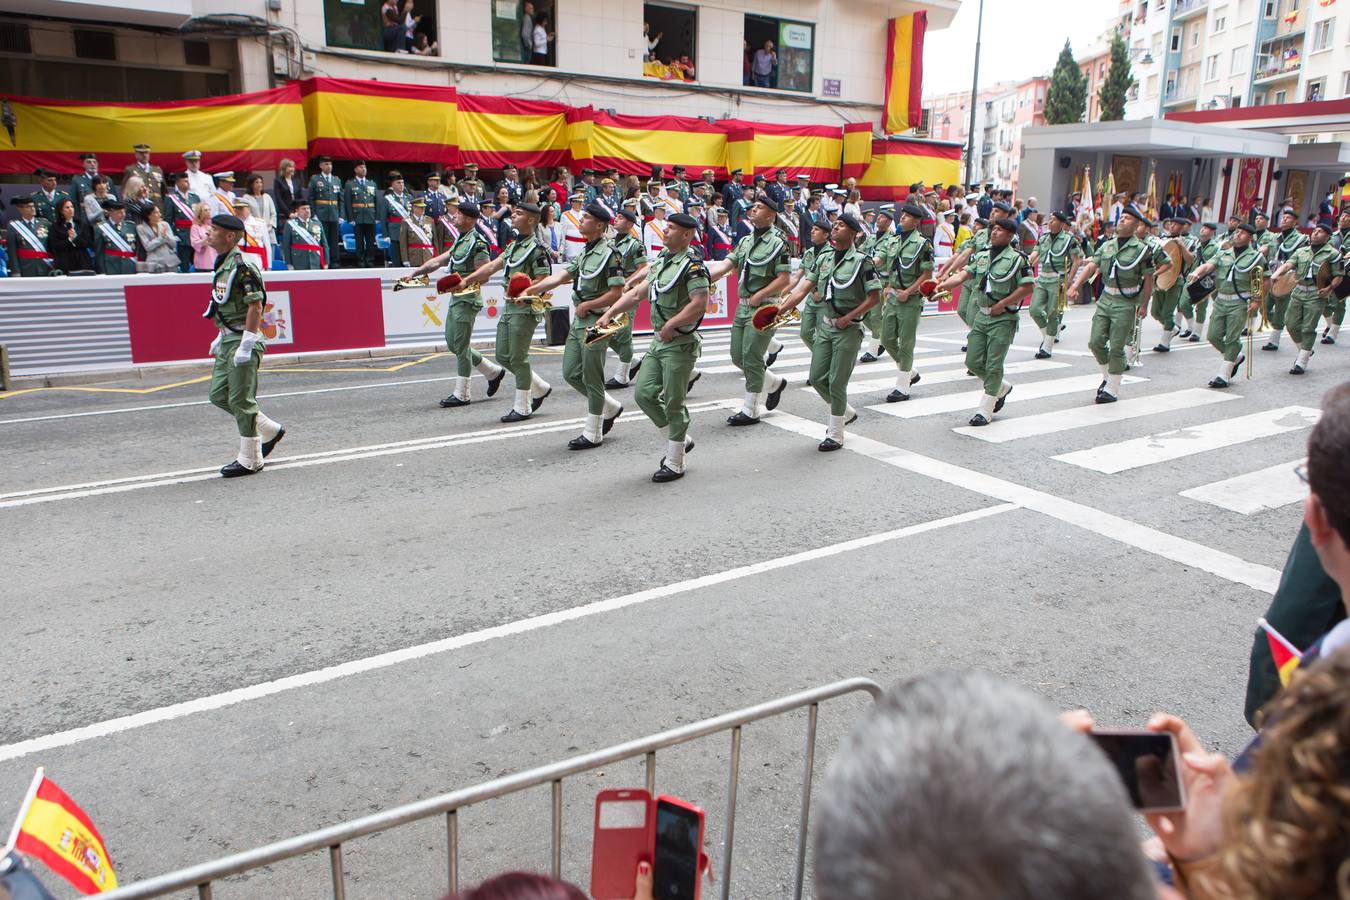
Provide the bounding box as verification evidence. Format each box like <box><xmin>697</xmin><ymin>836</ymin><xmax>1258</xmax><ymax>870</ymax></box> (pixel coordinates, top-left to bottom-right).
<box><xmin>101</xmin><ymin>679</ymin><xmax>882</xmax><ymax>900</ymax></box>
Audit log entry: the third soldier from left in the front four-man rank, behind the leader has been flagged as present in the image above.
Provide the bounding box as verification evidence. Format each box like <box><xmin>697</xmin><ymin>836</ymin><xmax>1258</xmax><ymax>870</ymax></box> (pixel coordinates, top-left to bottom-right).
<box><xmin>529</xmin><ymin>201</ymin><xmax>632</xmax><ymax>449</ymax></box>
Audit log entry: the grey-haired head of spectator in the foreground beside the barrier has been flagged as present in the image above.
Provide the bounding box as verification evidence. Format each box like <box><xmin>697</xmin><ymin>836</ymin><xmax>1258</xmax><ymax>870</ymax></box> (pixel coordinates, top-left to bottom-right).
<box><xmin>815</xmin><ymin>672</ymin><xmax>1158</xmax><ymax>900</ymax></box>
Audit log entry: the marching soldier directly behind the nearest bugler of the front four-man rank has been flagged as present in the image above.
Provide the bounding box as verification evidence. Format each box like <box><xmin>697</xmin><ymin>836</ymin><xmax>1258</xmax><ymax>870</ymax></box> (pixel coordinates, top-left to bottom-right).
<box><xmin>707</xmin><ymin>197</ymin><xmax>792</xmax><ymax>425</ymax></box>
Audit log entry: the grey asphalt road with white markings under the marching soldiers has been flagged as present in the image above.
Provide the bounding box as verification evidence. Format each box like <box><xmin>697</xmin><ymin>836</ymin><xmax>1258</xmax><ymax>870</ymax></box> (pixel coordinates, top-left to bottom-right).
<box><xmin>0</xmin><ymin>309</ymin><xmax>1333</xmax><ymax>897</ymax></box>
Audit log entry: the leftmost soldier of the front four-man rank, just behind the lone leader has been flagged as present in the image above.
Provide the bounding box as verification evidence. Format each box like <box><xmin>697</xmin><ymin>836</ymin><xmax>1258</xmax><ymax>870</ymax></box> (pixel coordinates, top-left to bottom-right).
<box><xmin>413</xmin><ymin>200</ymin><xmax>506</xmax><ymax>409</ymax></box>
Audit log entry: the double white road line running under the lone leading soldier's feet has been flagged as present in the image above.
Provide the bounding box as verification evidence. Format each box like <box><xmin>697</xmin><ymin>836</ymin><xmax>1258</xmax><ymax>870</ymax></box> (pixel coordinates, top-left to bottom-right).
<box><xmin>0</xmin><ymin>401</ymin><xmax>729</xmax><ymax>509</ymax></box>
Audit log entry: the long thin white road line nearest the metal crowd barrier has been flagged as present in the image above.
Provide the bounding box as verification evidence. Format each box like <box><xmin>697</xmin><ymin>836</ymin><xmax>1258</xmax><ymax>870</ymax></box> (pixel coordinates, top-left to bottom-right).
<box><xmin>0</xmin><ymin>503</ymin><xmax>1017</xmax><ymax>762</ymax></box>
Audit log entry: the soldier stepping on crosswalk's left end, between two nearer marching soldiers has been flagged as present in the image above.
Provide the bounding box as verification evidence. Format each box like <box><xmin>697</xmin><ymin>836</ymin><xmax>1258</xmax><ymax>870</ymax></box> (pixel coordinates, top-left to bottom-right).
<box><xmin>864</xmin><ymin>202</ymin><xmax>933</xmax><ymax>403</ymax></box>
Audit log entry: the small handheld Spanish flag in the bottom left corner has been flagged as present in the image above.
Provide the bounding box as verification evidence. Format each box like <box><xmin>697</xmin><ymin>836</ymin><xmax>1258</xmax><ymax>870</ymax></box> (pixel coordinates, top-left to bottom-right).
<box><xmin>0</xmin><ymin>769</ymin><xmax>117</xmax><ymax>893</ymax></box>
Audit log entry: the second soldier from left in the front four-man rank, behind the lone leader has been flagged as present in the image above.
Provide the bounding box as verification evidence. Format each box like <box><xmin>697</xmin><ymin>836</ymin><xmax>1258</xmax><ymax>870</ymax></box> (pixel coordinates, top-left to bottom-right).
<box><xmin>464</xmin><ymin>202</ymin><xmax>554</xmax><ymax>422</ymax></box>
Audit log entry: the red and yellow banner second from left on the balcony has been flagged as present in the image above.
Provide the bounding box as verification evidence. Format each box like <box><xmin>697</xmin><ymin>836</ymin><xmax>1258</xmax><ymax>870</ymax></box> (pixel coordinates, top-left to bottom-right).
<box><xmin>300</xmin><ymin>78</ymin><xmax>458</xmax><ymax>165</ymax></box>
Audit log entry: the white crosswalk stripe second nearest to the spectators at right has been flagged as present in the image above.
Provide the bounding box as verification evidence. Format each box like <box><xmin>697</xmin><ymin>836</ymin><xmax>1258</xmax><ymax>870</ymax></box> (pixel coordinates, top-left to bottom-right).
<box><xmin>1054</xmin><ymin>406</ymin><xmax>1322</xmax><ymax>475</ymax></box>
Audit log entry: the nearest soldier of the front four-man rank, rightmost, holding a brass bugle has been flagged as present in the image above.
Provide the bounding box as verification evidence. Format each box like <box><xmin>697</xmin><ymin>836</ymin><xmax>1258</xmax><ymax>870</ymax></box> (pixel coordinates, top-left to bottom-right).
<box><xmin>595</xmin><ymin>213</ymin><xmax>711</xmax><ymax>484</ymax></box>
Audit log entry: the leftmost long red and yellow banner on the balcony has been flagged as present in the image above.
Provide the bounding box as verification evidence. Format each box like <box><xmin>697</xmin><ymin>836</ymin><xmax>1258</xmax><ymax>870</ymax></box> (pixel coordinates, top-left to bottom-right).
<box><xmin>0</xmin><ymin>84</ymin><xmax>306</xmax><ymax>174</ymax></box>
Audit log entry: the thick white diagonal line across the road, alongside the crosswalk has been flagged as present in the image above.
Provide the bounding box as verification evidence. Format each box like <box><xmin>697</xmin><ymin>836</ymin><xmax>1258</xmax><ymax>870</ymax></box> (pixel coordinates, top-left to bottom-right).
<box><xmin>764</xmin><ymin>412</ymin><xmax>1280</xmax><ymax>594</ymax></box>
